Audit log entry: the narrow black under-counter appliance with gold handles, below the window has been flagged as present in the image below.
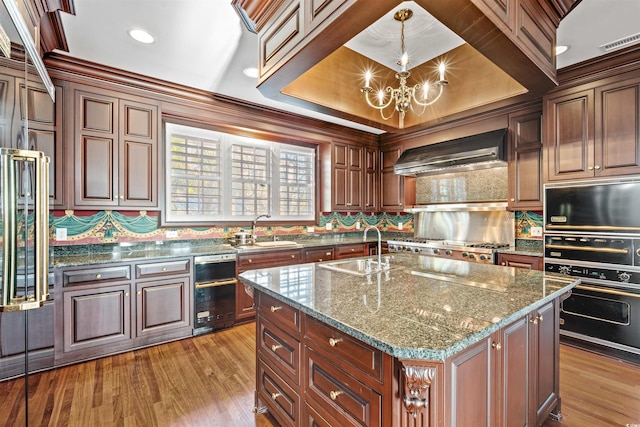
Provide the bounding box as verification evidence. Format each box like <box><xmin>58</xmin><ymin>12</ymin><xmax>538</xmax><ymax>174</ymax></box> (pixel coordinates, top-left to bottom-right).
<box><xmin>193</xmin><ymin>254</ymin><xmax>237</xmax><ymax>335</ymax></box>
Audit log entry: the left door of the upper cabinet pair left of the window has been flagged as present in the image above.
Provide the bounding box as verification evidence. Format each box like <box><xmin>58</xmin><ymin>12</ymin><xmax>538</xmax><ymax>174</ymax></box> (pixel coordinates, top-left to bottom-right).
<box><xmin>73</xmin><ymin>91</ymin><xmax>118</xmax><ymax>208</ymax></box>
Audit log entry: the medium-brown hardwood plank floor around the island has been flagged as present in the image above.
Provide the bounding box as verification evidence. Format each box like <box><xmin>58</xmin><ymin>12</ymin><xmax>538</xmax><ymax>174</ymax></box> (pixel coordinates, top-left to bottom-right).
<box><xmin>0</xmin><ymin>324</ymin><xmax>640</xmax><ymax>427</ymax></box>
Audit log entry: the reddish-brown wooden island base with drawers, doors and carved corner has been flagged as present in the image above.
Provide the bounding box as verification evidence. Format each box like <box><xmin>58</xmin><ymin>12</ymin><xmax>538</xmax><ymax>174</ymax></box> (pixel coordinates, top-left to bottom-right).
<box><xmin>254</xmin><ymin>290</ymin><xmax>560</xmax><ymax>427</ymax></box>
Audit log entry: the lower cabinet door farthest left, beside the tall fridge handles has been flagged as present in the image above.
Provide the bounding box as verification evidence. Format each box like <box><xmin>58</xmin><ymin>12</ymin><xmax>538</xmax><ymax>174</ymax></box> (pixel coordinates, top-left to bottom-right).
<box><xmin>62</xmin><ymin>284</ymin><xmax>131</xmax><ymax>353</ymax></box>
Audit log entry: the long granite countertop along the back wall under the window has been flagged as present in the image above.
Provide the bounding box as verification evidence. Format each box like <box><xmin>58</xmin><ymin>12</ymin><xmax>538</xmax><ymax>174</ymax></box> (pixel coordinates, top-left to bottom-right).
<box><xmin>50</xmin><ymin>232</ymin><xmax>396</xmax><ymax>268</ymax></box>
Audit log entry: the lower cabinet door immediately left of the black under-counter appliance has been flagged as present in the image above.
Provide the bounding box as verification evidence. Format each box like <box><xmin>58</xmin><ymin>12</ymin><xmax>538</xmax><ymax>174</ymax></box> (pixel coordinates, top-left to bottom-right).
<box><xmin>136</xmin><ymin>277</ymin><xmax>191</xmax><ymax>337</ymax></box>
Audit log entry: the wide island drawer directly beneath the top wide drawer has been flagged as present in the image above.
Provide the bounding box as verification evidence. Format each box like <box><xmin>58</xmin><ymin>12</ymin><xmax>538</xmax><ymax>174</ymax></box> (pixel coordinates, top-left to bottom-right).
<box><xmin>306</xmin><ymin>351</ymin><xmax>382</xmax><ymax>426</ymax></box>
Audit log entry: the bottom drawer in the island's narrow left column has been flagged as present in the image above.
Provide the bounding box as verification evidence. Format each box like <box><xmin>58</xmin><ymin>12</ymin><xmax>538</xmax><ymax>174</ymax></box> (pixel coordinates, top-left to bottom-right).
<box><xmin>258</xmin><ymin>359</ymin><xmax>302</xmax><ymax>426</ymax></box>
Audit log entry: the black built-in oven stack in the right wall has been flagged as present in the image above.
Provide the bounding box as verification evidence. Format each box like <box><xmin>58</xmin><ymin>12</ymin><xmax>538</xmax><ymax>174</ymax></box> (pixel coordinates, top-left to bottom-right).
<box><xmin>544</xmin><ymin>179</ymin><xmax>640</xmax><ymax>360</ymax></box>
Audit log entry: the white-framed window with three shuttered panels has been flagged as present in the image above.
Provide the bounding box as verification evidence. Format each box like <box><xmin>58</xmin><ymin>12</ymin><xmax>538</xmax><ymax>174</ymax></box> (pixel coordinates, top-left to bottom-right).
<box><xmin>165</xmin><ymin>123</ymin><xmax>315</xmax><ymax>223</ymax></box>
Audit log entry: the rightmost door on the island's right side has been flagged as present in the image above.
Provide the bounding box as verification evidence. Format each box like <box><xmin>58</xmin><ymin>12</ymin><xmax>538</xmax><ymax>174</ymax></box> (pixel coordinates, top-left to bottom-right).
<box><xmin>529</xmin><ymin>301</ymin><xmax>560</xmax><ymax>425</ymax></box>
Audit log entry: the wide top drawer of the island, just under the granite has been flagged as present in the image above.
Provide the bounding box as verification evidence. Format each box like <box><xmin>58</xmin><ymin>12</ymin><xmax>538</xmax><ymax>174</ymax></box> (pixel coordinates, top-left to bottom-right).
<box><xmin>306</xmin><ymin>316</ymin><xmax>383</xmax><ymax>382</ymax></box>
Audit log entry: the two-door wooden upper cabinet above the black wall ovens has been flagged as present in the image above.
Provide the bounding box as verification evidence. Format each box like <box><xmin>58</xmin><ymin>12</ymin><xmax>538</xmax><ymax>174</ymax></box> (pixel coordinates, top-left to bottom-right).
<box><xmin>544</xmin><ymin>72</ymin><xmax>640</xmax><ymax>181</ymax></box>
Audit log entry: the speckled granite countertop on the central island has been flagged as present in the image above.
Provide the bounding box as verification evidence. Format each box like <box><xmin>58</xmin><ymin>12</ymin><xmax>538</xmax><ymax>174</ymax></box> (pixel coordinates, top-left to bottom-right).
<box><xmin>240</xmin><ymin>254</ymin><xmax>580</xmax><ymax>361</ymax></box>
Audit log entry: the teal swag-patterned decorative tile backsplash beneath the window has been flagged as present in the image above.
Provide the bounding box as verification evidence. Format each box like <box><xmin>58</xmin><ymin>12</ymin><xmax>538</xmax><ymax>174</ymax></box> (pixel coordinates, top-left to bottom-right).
<box><xmin>51</xmin><ymin>210</ymin><xmax>413</xmax><ymax>245</ymax></box>
